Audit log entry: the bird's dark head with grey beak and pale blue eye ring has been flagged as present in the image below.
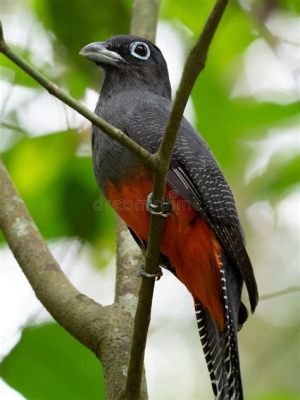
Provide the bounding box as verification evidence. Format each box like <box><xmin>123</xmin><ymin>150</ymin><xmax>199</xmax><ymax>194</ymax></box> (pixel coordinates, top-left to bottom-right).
<box><xmin>79</xmin><ymin>35</ymin><xmax>171</xmax><ymax>98</ymax></box>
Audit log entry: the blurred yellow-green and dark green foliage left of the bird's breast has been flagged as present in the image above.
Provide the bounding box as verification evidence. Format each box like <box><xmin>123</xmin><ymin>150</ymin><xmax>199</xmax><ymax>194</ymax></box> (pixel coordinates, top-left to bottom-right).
<box><xmin>3</xmin><ymin>131</ymin><xmax>114</xmax><ymax>244</ymax></box>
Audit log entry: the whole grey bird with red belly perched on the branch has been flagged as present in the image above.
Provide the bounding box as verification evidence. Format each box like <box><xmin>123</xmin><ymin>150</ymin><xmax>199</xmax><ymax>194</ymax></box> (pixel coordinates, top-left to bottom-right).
<box><xmin>80</xmin><ymin>35</ymin><xmax>258</xmax><ymax>400</ymax></box>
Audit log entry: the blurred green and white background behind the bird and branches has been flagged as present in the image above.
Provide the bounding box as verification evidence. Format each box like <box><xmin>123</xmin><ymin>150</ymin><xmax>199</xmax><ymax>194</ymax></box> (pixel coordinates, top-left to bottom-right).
<box><xmin>0</xmin><ymin>0</ymin><xmax>300</xmax><ymax>400</ymax></box>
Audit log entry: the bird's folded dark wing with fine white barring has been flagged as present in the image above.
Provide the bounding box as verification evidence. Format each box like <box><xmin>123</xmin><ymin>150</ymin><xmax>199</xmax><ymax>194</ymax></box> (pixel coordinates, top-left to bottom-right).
<box><xmin>168</xmin><ymin>153</ymin><xmax>258</xmax><ymax>311</ymax></box>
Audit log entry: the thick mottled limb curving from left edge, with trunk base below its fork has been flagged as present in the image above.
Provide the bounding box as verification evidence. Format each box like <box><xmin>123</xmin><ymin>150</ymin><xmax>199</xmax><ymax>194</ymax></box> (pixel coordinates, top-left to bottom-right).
<box><xmin>0</xmin><ymin>160</ymin><xmax>147</xmax><ymax>400</ymax></box>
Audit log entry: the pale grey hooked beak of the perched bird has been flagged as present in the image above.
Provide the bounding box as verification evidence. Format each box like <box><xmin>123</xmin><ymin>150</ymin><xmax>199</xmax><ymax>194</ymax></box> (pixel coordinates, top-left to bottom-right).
<box><xmin>79</xmin><ymin>42</ymin><xmax>126</xmax><ymax>65</ymax></box>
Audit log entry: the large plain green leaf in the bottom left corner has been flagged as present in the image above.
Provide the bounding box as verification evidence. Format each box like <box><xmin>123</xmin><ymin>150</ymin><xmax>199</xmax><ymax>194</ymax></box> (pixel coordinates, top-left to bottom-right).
<box><xmin>0</xmin><ymin>324</ymin><xmax>104</xmax><ymax>400</ymax></box>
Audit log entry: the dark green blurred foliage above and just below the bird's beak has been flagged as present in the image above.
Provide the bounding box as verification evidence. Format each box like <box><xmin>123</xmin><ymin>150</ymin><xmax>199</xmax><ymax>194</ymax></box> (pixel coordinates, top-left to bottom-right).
<box><xmin>33</xmin><ymin>0</ymin><xmax>130</xmax><ymax>97</ymax></box>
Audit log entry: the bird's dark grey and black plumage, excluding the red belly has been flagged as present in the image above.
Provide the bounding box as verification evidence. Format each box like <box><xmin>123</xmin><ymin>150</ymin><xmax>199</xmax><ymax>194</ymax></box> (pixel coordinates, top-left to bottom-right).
<box><xmin>83</xmin><ymin>36</ymin><xmax>258</xmax><ymax>400</ymax></box>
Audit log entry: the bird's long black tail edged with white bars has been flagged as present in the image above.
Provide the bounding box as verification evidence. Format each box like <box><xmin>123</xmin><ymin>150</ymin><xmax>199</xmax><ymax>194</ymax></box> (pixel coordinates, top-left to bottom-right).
<box><xmin>195</xmin><ymin>264</ymin><xmax>244</xmax><ymax>400</ymax></box>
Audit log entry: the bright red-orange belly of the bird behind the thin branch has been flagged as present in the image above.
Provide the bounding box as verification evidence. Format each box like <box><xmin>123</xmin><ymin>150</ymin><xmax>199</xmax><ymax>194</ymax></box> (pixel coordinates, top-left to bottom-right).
<box><xmin>107</xmin><ymin>175</ymin><xmax>224</xmax><ymax>329</ymax></box>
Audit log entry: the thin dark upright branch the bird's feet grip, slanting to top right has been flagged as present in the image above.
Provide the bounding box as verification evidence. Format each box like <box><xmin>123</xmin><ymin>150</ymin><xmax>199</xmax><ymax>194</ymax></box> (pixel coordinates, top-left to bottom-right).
<box><xmin>123</xmin><ymin>0</ymin><xmax>228</xmax><ymax>400</ymax></box>
